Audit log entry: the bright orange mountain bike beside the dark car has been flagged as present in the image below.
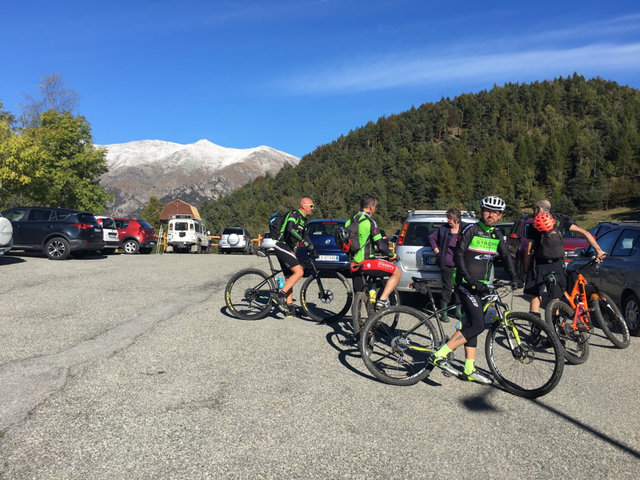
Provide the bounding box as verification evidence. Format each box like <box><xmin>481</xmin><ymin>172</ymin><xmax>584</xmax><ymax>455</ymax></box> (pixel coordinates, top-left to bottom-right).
<box><xmin>545</xmin><ymin>257</ymin><xmax>631</xmax><ymax>365</ymax></box>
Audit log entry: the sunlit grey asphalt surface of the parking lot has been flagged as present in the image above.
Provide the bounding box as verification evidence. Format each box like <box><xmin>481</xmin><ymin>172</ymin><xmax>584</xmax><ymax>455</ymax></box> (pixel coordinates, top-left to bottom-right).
<box><xmin>0</xmin><ymin>254</ymin><xmax>640</xmax><ymax>479</ymax></box>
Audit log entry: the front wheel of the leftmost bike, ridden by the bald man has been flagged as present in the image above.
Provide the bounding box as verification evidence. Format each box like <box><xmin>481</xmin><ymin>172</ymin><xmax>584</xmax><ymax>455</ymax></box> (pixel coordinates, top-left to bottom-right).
<box><xmin>300</xmin><ymin>270</ymin><xmax>353</xmax><ymax>323</ymax></box>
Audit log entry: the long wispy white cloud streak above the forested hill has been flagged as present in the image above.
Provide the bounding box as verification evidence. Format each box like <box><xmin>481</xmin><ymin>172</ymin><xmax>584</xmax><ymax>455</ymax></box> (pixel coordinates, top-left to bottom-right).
<box><xmin>280</xmin><ymin>15</ymin><xmax>640</xmax><ymax>94</ymax></box>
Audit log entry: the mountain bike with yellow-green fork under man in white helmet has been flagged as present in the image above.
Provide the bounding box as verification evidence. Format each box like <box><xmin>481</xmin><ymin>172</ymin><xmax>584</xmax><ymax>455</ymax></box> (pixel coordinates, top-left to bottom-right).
<box><xmin>360</xmin><ymin>279</ymin><xmax>564</xmax><ymax>398</ymax></box>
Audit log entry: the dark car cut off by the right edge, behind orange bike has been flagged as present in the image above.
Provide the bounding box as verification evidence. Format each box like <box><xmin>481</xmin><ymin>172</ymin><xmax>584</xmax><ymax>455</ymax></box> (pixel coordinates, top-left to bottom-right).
<box><xmin>570</xmin><ymin>222</ymin><xmax>640</xmax><ymax>336</ymax></box>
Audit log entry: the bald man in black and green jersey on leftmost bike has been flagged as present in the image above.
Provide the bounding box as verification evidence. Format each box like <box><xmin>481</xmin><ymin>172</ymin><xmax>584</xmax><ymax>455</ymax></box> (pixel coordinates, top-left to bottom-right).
<box><xmin>274</xmin><ymin>197</ymin><xmax>318</xmax><ymax>317</ymax></box>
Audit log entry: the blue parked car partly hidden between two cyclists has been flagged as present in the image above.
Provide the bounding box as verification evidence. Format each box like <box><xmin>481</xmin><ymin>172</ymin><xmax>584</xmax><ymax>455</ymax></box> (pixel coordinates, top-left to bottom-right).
<box><xmin>296</xmin><ymin>218</ymin><xmax>350</xmax><ymax>272</ymax></box>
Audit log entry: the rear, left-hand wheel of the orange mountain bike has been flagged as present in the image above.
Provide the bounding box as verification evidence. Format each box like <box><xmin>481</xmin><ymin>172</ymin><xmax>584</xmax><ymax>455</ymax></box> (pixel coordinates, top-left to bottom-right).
<box><xmin>545</xmin><ymin>300</ymin><xmax>589</xmax><ymax>365</ymax></box>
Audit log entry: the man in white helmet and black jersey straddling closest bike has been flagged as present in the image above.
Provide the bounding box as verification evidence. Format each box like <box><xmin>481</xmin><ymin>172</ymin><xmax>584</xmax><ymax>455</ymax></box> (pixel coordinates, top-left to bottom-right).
<box><xmin>431</xmin><ymin>196</ymin><xmax>522</xmax><ymax>383</ymax></box>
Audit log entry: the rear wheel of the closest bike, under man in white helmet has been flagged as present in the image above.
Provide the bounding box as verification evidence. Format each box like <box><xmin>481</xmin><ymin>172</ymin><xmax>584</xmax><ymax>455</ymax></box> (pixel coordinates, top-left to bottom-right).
<box><xmin>359</xmin><ymin>305</ymin><xmax>442</xmax><ymax>386</ymax></box>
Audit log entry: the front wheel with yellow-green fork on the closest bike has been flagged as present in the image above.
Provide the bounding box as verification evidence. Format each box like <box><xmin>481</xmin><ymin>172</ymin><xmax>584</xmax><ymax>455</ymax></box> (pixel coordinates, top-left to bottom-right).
<box><xmin>485</xmin><ymin>312</ymin><xmax>564</xmax><ymax>398</ymax></box>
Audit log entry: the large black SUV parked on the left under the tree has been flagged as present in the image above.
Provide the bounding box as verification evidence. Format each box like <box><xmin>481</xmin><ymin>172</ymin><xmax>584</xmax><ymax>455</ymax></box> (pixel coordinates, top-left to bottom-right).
<box><xmin>2</xmin><ymin>207</ymin><xmax>104</xmax><ymax>260</ymax></box>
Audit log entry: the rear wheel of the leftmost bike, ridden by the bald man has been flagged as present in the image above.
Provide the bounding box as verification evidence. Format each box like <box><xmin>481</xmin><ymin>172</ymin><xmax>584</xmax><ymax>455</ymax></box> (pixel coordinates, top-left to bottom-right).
<box><xmin>224</xmin><ymin>268</ymin><xmax>276</xmax><ymax>320</ymax></box>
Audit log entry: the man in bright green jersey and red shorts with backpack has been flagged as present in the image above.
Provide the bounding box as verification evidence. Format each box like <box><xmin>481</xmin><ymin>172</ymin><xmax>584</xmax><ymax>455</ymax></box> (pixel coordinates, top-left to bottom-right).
<box><xmin>345</xmin><ymin>193</ymin><xmax>402</xmax><ymax>310</ymax></box>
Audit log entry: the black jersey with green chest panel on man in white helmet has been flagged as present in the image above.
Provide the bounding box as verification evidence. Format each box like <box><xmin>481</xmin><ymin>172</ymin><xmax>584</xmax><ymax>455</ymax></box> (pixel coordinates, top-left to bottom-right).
<box><xmin>453</xmin><ymin>221</ymin><xmax>518</xmax><ymax>285</ymax></box>
